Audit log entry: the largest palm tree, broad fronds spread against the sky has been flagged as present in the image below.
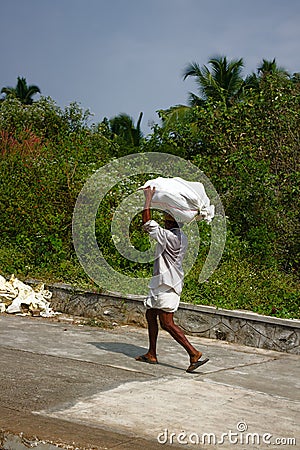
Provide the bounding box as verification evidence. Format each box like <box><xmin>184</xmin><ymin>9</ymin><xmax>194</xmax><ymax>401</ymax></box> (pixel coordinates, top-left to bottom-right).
<box><xmin>183</xmin><ymin>56</ymin><xmax>244</xmax><ymax>106</ymax></box>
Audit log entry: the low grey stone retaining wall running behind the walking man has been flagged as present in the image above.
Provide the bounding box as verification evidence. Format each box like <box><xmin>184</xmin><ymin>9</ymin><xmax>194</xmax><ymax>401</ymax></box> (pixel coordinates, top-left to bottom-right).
<box><xmin>47</xmin><ymin>284</ymin><xmax>300</xmax><ymax>354</ymax></box>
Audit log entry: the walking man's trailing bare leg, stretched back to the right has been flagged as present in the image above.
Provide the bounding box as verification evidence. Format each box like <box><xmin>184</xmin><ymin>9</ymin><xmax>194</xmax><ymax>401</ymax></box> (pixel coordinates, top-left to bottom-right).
<box><xmin>159</xmin><ymin>310</ymin><xmax>202</xmax><ymax>363</ymax></box>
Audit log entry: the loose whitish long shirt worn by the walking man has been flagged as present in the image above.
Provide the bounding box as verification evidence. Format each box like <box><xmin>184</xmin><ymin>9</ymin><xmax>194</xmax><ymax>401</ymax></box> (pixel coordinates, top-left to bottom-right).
<box><xmin>143</xmin><ymin>220</ymin><xmax>188</xmax><ymax>295</ymax></box>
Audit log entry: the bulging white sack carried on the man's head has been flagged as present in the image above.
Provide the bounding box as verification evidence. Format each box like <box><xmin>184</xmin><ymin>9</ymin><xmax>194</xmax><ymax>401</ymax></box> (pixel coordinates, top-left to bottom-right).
<box><xmin>139</xmin><ymin>177</ymin><xmax>215</xmax><ymax>223</ymax></box>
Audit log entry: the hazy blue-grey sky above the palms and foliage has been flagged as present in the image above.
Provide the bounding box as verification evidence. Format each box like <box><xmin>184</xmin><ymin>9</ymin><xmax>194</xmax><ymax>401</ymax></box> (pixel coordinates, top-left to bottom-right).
<box><xmin>0</xmin><ymin>0</ymin><xmax>300</xmax><ymax>134</ymax></box>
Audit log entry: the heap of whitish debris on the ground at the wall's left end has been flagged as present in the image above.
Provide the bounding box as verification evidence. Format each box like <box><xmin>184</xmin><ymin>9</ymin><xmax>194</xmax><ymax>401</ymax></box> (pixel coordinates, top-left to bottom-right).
<box><xmin>0</xmin><ymin>275</ymin><xmax>60</xmax><ymax>317</ymax></box>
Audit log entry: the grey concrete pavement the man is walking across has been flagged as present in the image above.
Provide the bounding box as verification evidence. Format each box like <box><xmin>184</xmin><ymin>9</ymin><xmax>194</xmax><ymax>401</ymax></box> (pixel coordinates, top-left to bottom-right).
<box><xmin>0</xmin><ymin>314</ymin><xmax>300</xmax><ymax>450</ymax></box>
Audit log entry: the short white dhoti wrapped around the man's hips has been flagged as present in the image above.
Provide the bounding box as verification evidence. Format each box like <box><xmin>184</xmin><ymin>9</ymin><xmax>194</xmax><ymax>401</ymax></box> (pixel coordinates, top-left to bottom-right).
<box><xmin>144</xmin><ymin>284</ymin><xmax>180</xmax><ymax>312</ymax></box>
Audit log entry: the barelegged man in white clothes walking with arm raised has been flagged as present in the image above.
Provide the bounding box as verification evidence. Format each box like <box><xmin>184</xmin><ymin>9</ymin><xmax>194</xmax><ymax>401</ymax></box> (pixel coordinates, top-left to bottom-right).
<box><xmin>136</xmin><ymin>187</ymin><xmax>209</xmax><ymax>373</ymax></box>
